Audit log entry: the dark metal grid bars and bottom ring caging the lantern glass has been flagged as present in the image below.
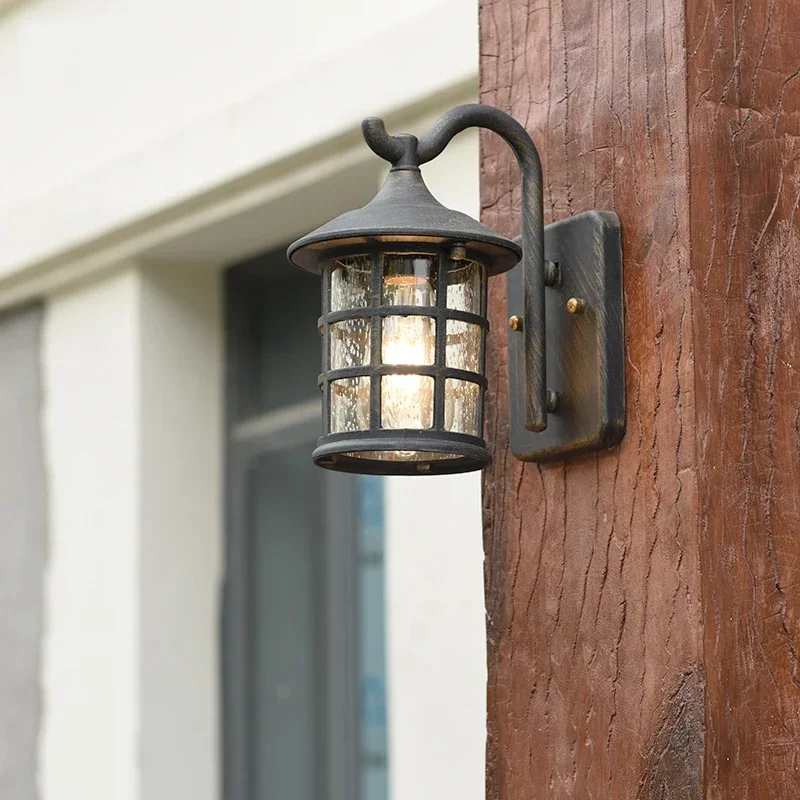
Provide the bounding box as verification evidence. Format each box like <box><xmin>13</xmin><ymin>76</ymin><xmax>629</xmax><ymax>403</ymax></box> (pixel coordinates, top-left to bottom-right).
<box><xmin>313</xmin><ymin>245</ymin><xmax>491</xmax><ymax>475</ymax></box>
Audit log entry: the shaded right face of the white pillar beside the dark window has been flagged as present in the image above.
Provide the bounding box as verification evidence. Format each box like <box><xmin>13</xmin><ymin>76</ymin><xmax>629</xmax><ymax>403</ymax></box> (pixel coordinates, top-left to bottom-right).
<box><xmin>139</xmin><ymin>267</ymin><xmax>224</xmax><ymax>800</ymax></box>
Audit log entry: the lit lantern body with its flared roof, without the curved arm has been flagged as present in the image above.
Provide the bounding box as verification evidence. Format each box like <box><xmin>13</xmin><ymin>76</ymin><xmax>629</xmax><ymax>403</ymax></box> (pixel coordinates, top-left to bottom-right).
<box><xmin>289</xmin><ymin>146</ymin><xmax>520</xmax><ymax>475</ymax></box>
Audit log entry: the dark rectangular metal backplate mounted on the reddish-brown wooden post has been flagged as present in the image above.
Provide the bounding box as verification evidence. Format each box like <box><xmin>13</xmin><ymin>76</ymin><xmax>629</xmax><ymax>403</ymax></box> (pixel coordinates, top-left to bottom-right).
<box><xmin>507</xmin><ymin>211</ymin><xmax>625</xmax><ymax>461</ymax></box>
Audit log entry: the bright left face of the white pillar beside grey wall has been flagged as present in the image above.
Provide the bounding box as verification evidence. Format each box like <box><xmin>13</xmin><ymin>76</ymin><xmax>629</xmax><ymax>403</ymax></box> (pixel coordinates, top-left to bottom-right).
<box><xmin>38</xmin><ymin>271</ymin><xmax>140</xmax><ymax>800</ymax></box>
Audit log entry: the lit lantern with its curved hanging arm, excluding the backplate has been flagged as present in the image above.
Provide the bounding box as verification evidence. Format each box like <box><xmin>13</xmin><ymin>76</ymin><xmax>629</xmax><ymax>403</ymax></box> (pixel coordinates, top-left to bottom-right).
<box><xmin>287</xmin><ymin>105</ymin><xmax>621</xmax><ymax>475</ymax></box>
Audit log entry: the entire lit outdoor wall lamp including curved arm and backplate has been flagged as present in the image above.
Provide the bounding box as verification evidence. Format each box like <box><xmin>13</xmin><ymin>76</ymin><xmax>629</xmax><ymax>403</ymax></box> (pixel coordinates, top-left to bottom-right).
<box><xmin>287</xmin><ymin>105</ymin><xmax>625</xmax><ymax>475</ymax></box>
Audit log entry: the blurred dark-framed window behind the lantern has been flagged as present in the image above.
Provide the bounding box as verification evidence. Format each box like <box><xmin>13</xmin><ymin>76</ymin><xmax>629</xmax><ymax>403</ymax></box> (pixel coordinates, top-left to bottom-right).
<box><xmin>223</xmin><ymin>250</ymin><xmax>387</xmax><ymax>800</ymax></box>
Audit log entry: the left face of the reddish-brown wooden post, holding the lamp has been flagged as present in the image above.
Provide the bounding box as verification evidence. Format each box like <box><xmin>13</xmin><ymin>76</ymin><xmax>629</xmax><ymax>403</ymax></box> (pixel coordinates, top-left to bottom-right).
<box><xmin>481</xmin><ymin>0</ymin><xmax>703</xmax><ymax>800</ymax></box>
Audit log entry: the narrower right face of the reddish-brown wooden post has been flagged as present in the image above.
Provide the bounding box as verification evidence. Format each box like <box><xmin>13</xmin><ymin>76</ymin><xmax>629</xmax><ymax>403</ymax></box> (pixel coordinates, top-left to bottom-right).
<box><xmin>687</xmin><ymin>0</ymin><xmax>800</xmax><ymax>800</ymax></box>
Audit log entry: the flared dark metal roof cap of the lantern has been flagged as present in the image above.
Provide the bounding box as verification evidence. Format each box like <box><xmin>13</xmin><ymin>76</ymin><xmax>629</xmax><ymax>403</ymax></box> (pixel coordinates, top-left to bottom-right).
<box><xmin>287</xmin><ymin>165</ymin><xmax>522</xmax><ymax>274</ymax></box>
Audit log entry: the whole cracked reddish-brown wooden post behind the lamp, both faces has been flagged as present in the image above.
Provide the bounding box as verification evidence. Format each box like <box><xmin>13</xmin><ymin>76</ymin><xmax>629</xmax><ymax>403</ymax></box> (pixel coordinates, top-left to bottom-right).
<box><xmin>481</xmin><ymin>0</ymin><xmax>800</xmax><ymax>800</ymax></box>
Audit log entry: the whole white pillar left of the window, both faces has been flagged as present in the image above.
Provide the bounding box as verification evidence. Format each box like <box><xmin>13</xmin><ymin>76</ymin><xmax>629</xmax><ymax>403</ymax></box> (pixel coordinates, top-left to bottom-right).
<box><xmin>39</xmin><ymin>265</ymin><xmax>223</xmax><ymax>800</ymax></box>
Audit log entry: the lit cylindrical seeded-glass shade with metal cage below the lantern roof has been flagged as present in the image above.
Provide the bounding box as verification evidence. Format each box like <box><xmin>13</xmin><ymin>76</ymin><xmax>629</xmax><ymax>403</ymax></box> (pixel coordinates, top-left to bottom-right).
<box><xmin>314</xmin><ymin>246</ymin><xmax>489</xmax><ymax>474</ymax></box>
